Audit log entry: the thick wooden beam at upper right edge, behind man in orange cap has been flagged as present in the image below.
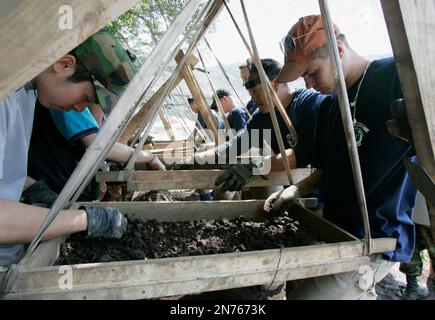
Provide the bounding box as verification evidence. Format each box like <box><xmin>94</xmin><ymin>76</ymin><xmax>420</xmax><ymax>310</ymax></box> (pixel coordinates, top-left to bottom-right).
<box><xmin>381</xmin><ymin>0</ymin><xmax>435</xmax><ymax>238</ymax></box>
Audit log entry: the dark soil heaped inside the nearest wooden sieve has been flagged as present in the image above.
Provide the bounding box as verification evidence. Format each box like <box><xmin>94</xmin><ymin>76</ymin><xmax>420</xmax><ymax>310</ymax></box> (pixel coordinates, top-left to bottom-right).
<box><xmin>56</xmin><ymin>213</ymin><xmax>316</xmax><ymax>265</ymax></box>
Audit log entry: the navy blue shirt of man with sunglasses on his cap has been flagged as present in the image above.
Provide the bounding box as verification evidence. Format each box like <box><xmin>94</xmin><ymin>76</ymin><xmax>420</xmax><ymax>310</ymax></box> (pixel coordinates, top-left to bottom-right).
<box><xmin>216</xmin><ymin>90</ymin><xmax>325</xmax><ymax>167</ymax></box>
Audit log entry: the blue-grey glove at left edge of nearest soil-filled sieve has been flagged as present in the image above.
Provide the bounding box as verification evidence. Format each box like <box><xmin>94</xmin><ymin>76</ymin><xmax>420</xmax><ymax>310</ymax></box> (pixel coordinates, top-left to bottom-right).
<box><xmin>84</xmin><ymin>208</ymin><xmax>127</xmax><ymax>239</ymax></box>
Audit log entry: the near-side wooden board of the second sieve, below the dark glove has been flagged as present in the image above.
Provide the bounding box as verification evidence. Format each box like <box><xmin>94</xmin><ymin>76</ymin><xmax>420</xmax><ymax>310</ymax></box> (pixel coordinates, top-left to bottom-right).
<box><xmin>96</xmin><ymin>169</ymin><xmax>311</xmax><ymax>191</ymax></box>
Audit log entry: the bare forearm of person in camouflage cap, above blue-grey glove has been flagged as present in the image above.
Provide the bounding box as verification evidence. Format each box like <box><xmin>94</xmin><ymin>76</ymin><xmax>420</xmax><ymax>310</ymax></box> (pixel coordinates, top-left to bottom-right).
<box><xmin>0</xmin><ymin>199</ymin><xmax>88</xmax><ymax>244</ymax></box>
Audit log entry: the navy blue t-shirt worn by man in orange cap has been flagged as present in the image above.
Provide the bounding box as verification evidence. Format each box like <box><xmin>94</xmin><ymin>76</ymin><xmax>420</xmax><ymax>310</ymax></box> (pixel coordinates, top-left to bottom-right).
<box><xmin>313</xmin><ymin>58</ymin><xmax>416</xmax><ymax>262</ymax></box>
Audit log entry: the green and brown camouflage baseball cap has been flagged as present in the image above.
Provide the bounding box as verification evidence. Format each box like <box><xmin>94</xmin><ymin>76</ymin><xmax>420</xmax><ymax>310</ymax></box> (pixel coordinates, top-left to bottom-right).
<box><xmin>73</xmin><ymin>29</ymin><xmax>137</xmax><ymax>114</ymax></box>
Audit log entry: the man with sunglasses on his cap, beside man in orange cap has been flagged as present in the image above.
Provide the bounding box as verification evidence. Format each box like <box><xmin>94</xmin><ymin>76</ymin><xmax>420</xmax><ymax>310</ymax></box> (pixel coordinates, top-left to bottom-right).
<box><xmin>195</xmin><ymin>59</ymin><xmax>325</xmax><ymax>191</ymax></box>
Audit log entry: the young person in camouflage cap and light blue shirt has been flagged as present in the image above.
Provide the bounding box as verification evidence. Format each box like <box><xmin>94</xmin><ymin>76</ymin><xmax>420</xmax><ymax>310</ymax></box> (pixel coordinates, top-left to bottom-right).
<box><xmin>0</xmin><ymin>31</ymin><xmax>156</xmax><ymax>267</ymax></box>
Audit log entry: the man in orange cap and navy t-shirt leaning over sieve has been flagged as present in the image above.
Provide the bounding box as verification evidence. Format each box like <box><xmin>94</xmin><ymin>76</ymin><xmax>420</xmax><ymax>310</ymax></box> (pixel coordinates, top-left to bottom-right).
<box><xmin>265</xmin><ymin>16</ymin><xmax>416</xmax><ymax>299</ymax></box>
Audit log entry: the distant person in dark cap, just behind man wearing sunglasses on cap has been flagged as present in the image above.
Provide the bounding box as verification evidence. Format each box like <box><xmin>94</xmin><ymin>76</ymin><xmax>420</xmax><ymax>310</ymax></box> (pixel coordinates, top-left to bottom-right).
<box><xmin>210</xmin><ymin>89</ymin><xmax>248</xmax><ymax>133</ymax></box>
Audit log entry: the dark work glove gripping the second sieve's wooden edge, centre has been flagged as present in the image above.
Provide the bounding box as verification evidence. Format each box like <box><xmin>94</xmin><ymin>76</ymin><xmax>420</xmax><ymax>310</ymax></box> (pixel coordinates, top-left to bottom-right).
<box><xmin>215</xmin><ymin>160</ymin><xmax>267</xmax><ymax>192</ymax></box>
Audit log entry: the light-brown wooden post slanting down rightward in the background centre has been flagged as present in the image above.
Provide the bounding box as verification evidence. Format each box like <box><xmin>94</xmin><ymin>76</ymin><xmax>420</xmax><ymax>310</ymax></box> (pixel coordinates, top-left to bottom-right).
<box><xmin>175</xmin><ymin>51</ymin><xmax>218</xmax><ymax>141</ymax></box>
